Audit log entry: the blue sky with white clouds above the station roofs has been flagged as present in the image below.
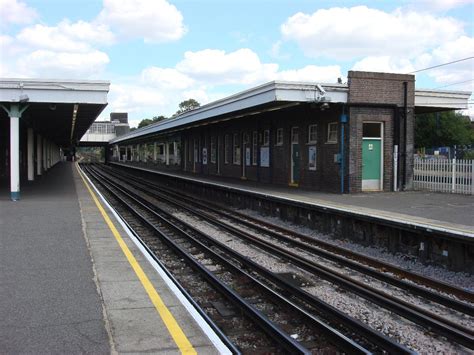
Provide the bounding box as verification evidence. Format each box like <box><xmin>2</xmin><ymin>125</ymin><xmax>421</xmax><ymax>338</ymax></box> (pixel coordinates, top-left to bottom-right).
<box><xmin>0</xmin><ymin>0</ymin><xmax>474</xmax><ymax>126</ymax></box>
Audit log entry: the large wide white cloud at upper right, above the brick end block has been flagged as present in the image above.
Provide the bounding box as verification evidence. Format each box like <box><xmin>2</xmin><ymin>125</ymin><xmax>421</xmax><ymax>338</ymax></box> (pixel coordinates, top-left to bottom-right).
<box><xmin>281</xmin><ymin>6</ymin><xmax>463</xmax><ymax>60</ymax></box>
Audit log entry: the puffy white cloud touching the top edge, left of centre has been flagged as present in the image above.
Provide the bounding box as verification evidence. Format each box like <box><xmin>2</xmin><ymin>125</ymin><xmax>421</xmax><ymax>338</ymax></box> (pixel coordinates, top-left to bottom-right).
<box><xmin>97</xmin><ymin>0</ymin><xmax>186</xmax><ymax>42</ymax></box>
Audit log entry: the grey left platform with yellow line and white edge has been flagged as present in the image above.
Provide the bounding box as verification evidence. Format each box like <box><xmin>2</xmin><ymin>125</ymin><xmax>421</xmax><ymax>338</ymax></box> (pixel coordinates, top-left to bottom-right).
<box><xmin>0</xmin><ymin>162</ymin><xmax>228</xmax><ymax>354</ymax></box>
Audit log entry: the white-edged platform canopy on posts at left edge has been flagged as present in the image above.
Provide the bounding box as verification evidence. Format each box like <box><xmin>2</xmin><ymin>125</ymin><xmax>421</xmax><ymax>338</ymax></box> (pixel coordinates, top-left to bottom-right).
<box><xmin>0</xmin><ymin>78</ymin><xmax>110</xmax><ymax>147</ymax></box>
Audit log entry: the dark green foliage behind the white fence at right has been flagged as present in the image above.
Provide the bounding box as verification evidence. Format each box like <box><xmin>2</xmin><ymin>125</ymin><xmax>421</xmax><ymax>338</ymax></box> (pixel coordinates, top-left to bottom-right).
<box><xmin>415</xmin><ymin>111</ymin><xmax>474</xmax><ymax>148</ymax></box>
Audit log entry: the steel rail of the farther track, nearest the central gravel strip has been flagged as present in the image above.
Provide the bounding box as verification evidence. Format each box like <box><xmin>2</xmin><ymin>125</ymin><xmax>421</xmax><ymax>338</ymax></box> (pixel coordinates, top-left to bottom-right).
<box><xmin>93</xmin><ymin>167</ymin><xmax>474</xmax><ymax>349</ymax></box>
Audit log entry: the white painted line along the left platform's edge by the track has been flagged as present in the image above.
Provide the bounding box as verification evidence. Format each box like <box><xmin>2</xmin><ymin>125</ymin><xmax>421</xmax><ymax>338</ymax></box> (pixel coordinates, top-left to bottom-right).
<box><xmin>79</xmin><ymin>167</ymin><xmax>232</xmax><ymax>355</ymax></box>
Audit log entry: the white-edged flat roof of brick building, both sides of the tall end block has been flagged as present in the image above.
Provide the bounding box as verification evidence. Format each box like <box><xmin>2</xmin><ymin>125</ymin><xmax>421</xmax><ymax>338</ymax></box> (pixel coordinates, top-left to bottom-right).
<box><xmin>109</xmin><ymin>81</ymin><xmax>471</xmax><ymax>144</ymax></box>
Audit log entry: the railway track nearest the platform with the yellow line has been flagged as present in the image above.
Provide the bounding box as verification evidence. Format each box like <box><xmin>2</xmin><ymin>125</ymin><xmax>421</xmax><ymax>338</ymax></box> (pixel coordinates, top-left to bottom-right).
<box><xmin>80</xmin><ymin>168</ymin><xmax>411</xmax><ymax>353</ymax></box>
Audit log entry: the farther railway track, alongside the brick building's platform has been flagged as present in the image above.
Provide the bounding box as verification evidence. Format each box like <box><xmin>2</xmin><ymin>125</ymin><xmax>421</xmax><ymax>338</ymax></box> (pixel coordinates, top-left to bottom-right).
<box><xmin>83</xmin><ymin>164</ymin><xmax>474</xmax><ymax>350</ymax></box>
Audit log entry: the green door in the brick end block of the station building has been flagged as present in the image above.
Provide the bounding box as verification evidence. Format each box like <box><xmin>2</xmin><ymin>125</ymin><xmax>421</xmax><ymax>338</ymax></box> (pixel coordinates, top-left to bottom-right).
<box><xmin>362</xmin><ymin>138</ymin><xmax>382</xmax><ymax>190</ymax></box>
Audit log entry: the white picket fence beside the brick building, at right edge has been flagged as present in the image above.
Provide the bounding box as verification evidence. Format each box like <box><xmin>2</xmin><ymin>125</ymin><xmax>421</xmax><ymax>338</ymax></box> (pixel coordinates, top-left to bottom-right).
<box><xmin>413</xmin><ymin>158</ymin><xmax>474</xmax><ymax>195</ymax></box>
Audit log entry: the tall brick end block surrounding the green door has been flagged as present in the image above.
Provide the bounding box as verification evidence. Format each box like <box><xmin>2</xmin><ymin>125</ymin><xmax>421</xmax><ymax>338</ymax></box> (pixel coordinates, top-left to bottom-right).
<box><xmin>348</xmin><ymin>71</ymin><xmax>415</xmax><ymax>192</ymax></box>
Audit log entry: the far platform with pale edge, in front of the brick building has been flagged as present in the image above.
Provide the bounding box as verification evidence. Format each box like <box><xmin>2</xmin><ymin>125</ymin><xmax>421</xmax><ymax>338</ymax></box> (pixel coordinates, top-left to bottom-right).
<box><xmin>112</xmin><ymin>163</ymin><xmax>474</xmax><ymax>240</ymax></box>
